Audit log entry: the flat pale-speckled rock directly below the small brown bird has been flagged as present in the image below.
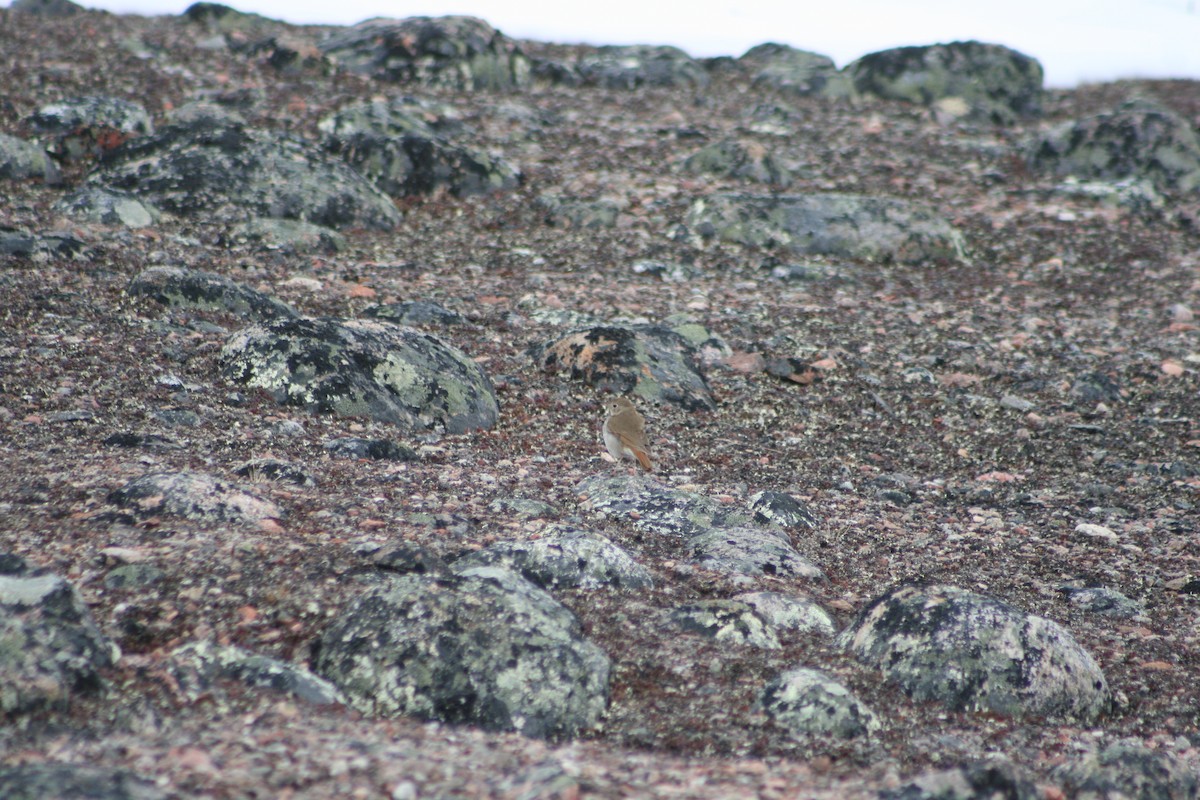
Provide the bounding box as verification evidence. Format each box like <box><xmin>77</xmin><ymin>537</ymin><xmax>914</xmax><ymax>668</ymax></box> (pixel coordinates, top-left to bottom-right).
<box><xmin>576</xmin><ymin>475</ymin><xmax>753</xmax><ymax>537</ymax></box>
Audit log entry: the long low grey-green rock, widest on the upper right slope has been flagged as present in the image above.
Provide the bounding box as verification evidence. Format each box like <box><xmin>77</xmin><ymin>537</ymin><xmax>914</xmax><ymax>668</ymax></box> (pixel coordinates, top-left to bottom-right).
<box><xmin>685</xmin><ymin>194</ymin><xmax>964</xmax><ymax>263</ymax></box>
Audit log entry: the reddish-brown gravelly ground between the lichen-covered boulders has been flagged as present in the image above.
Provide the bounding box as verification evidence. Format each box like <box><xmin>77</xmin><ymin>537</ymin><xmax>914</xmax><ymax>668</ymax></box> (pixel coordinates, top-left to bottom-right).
<box><xmin>0</xmin><ymin>1</ymin><xmax>1200</xmax><ymax>798</ymax></box>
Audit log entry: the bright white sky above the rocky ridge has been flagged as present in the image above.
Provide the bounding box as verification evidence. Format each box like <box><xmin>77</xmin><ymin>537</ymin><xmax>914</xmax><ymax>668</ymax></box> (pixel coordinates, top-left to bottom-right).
<box><xmin>11</xmin><ymin>0</ymin><xmax>1200</xmax><ymax>86</ymax></box>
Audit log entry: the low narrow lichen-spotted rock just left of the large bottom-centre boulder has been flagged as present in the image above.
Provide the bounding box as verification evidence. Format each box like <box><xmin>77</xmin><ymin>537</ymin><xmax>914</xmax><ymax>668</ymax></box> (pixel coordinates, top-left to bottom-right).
<box><xmin>168</xmin><ymin>640</ymin><xmax>346</xmax><ymax>705</ymax></box>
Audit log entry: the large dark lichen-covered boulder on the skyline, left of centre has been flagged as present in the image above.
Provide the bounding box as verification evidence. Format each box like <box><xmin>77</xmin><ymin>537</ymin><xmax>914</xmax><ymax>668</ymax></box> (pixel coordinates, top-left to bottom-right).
<box><xmin>320</xmin><ymin>17</ymin><xmax>529</xmax><ymax>90</ymax></box>
